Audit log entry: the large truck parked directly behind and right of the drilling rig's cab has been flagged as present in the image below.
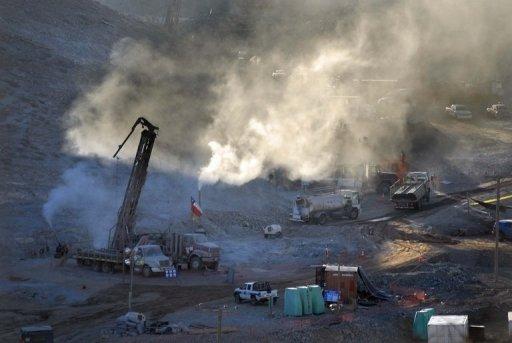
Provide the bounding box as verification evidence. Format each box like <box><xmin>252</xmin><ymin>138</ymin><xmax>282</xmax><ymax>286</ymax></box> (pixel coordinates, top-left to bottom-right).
<box><xmin>136</xmin><ymin>232</ymin><xmax>220</xmax><ymax>271</ymax></box>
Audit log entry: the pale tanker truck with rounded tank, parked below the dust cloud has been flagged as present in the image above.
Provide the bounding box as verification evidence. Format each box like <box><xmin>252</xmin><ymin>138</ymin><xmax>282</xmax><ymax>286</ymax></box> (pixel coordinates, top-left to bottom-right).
<box><xmin>290</xmin><ymin>190</ymin><xmax>361</xmax><ymax>225</ymax></box>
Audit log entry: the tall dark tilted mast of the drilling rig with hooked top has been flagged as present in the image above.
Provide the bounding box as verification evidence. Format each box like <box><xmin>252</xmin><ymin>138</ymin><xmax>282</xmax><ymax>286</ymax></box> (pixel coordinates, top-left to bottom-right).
<box><xmin>109</xmin><ymin>117</ymin><xmax>158</xmax><ymax>251</ymax></box>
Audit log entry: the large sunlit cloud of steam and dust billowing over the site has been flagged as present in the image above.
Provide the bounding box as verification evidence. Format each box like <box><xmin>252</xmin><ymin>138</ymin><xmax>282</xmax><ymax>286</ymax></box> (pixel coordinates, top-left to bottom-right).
<box><xmin>45</xmin><ymin>0</ymin><xmax>512</xmax><ymax>239</ymax></box>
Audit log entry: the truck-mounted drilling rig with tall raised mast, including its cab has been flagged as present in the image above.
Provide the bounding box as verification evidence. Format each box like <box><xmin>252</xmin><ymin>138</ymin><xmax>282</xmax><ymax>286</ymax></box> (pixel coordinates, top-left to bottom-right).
<box><xmin>75</xmin><ymin>117</ymin><xmax>170</xmax><ymax>276</ymax></box>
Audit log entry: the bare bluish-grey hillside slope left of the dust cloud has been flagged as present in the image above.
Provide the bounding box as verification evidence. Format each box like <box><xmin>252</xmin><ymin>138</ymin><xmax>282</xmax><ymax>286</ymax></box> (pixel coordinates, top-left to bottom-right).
<box><xmin>0</xmin><ymin>0</ymin><xmax>169</xmax><ymax>256</ymax></box>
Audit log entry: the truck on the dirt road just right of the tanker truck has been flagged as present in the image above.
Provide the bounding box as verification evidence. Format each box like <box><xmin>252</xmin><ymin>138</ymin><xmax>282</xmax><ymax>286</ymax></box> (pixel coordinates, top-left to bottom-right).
<box><xmin>391</xmin><ymin>172</ymin><xmax>431</xmax><ymax>210</ymax></box>
